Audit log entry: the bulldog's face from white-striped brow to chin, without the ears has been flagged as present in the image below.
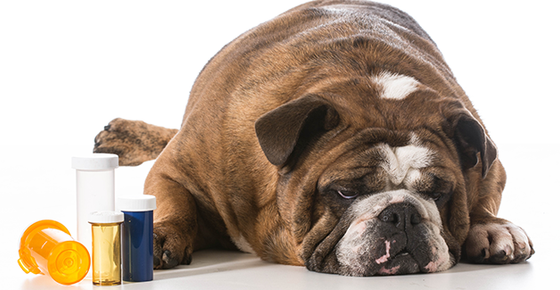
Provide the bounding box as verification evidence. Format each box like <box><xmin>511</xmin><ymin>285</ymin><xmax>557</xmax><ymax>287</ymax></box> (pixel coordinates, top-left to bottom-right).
<box><xmin>308</xmin><ymin>129</ymin><xmax>461</xmax><ymax>276</ymax></box>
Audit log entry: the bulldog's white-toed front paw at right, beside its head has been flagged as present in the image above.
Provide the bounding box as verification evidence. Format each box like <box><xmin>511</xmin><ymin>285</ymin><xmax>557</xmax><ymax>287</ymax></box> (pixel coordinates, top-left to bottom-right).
<box><xmin>464</xmin><ymin>222</ymin><xmax>535</xmax><ymax>264</ymax></box>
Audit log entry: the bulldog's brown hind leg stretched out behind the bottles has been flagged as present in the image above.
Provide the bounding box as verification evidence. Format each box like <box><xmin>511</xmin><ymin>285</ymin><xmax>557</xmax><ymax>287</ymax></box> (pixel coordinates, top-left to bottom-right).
<box><xmin>93</xmin><ymin>118</ymin><xmax>178</xmax><ymax>166</ymax></box>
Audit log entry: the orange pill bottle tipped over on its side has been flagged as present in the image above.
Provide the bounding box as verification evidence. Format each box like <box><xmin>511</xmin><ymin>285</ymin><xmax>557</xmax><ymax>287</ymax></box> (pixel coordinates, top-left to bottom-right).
<box><xmin>18</xmin><ymin>220</ymin><xmax>90</xmax><ymax>285</ymax></box>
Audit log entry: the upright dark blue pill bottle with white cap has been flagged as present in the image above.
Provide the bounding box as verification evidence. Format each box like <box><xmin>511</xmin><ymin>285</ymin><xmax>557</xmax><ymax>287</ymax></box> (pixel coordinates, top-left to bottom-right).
<box><xmin>117</xmin><ymin>195</ymin><xmax>156</xmax><ymax>282</ymax></box>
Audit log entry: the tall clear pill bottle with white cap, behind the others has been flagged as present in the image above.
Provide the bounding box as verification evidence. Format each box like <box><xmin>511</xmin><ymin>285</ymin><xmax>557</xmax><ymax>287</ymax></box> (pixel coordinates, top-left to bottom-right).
<box><xmin>72</xmin><ymin>153</ymin><xmax>119</xmax><ymax>258</ymax></box>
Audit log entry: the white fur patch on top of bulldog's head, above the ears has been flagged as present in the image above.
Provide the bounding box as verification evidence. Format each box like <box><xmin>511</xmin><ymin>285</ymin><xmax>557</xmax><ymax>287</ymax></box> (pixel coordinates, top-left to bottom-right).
<box><xmin>371</xmin><ymin>71</ymin><xmax>420</xmax><ymax>100</ymax></box>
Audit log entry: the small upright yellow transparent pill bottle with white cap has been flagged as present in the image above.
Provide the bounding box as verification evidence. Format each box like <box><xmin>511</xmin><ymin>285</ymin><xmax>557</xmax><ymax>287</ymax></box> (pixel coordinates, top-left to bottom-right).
<box><xmin>89</xmin><ymin>211</ymin><xmax>123</xmax><ymax>286</ymax></box>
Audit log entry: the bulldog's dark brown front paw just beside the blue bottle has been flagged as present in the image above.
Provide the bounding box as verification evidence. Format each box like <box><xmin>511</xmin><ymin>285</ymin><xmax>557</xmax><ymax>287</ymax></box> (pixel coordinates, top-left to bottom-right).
<box><xmin>154</xmin><ymin>222</ymin><xmax>193</xmax><ymax>269</ymax></box>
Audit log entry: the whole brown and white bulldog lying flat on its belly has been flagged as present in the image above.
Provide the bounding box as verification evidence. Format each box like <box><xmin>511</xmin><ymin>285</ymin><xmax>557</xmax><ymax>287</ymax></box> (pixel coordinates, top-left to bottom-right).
<box><xmin>94</xmin><ymin>1</ymin><xmax>534</xmax><ymax>276</ymax></box>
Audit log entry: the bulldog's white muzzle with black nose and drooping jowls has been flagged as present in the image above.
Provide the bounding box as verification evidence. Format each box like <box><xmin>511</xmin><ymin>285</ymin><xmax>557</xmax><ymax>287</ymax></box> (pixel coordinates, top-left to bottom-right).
<box><xmin>335</xmin><ymin>190</ymin><xmax>454</xmax><ymax>276</ymax></box>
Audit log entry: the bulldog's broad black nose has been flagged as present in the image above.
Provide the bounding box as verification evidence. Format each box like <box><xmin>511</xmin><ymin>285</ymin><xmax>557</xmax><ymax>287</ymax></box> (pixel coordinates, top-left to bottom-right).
<box><xmin>378</xmin><ymin>203</ymin><xmax>422</xmax><ymax>231</ymax></box>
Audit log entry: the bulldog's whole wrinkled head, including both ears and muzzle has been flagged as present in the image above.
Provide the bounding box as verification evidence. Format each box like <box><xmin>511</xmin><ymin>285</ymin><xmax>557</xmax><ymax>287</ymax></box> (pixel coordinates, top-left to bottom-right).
<box><xmin>256</xmin><ymin>74</ymin><xmax>496</xmax><ymax>276</ymax></box>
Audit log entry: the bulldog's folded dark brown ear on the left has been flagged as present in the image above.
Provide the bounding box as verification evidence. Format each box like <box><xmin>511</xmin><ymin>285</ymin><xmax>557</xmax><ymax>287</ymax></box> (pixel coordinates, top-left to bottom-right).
<box><xmin>255</xmin><ymin>95</ymin><xmax>339</xmax><ymax>166</ymax></box>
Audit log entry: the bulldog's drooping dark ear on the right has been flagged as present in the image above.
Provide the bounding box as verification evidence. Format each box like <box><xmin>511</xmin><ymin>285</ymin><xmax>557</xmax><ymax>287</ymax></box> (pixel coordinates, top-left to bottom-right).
<box><xmin>446</xmin><ymin>103</ymin><xmax>498</xmax><ymax>178</ymax></box>
